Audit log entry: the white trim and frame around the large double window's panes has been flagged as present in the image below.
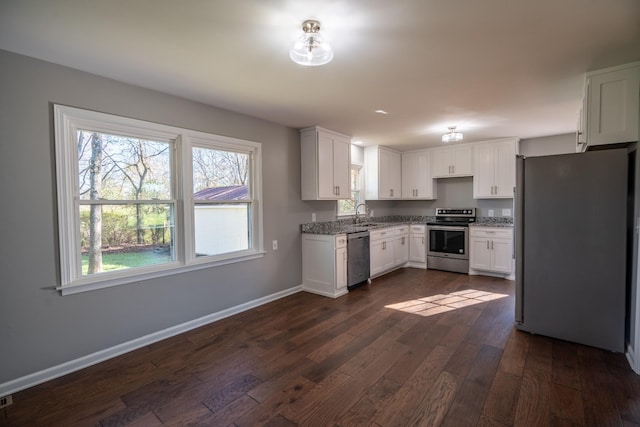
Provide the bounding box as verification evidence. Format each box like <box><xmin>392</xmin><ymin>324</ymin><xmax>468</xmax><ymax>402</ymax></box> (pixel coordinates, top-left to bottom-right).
<box><xmin>53</xmin><ymin>105</ymin><xmax>265</xmax><ymax>295</ymax></box>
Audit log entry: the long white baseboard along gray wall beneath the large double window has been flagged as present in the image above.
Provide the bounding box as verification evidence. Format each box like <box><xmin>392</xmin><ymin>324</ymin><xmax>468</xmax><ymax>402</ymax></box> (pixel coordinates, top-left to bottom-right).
<box><xmin>0</xmin><ymin>285</ymin><xmax>302</xmax><ymax>396</ymax></box>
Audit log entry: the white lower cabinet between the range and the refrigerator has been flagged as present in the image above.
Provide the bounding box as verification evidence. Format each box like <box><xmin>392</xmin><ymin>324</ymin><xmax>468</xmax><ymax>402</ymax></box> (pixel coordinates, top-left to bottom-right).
<box><xmin>469</xmin><ymin>226</ymin><xmax>513</xmax><ymax>279</ymax></box>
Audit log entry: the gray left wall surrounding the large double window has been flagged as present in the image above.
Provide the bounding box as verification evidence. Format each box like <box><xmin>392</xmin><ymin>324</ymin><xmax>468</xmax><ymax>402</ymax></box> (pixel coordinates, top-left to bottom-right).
<box><xmin>0</xmin><ymin>51</ymin><xmax>335</xmax><ymax>384</ymax></box>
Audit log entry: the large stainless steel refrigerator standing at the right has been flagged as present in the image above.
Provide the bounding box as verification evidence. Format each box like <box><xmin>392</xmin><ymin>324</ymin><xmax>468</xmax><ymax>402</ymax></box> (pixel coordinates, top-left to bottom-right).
<box><xmin>515</xmin><ymin>149</ymin><xmax>628</xmax><ymax>352</ymax></box>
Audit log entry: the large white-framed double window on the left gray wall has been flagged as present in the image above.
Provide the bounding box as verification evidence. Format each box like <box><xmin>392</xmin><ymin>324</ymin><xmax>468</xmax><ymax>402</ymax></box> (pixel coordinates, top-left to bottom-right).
<box><xmin>54</xmin><ymin>105</ymin><xmax>263</xmax><ymax>295</ymax></box>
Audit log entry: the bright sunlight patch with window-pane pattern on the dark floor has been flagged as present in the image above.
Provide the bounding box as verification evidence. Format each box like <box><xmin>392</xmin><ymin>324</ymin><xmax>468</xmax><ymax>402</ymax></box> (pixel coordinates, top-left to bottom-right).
<box><xmin>385</xmin><ymin>289</ymin><xmax>508</xmax><ymax>317</ymax></box>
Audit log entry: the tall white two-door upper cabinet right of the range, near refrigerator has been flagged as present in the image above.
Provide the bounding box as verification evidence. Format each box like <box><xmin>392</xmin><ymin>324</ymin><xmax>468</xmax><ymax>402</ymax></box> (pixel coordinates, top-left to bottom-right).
<box><xmin>473</xmin><ymin>138</ymin><xmax>518</xmax><ymax>199</ymax></box>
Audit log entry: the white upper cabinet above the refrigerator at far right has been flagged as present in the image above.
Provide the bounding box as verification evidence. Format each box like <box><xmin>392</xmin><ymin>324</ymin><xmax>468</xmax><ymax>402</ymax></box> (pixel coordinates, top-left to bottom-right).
<box><xmin>578</xmin><ymin>62</ymin><xmax>640</xmax><ymax>149</ymax></box>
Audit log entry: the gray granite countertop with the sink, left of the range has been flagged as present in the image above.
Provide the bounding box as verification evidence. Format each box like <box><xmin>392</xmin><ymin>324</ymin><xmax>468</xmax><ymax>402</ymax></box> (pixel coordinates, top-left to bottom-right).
<box><xmin>300</xmin><ymin>215</ymin><xmax>434</xmax><ymax>235</ymax></box>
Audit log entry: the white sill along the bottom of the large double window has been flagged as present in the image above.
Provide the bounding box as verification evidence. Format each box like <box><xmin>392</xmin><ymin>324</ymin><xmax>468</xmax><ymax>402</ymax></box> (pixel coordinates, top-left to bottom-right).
<box><xmin>56</xmin><ymin>251</ymin><xmax>266</xmax><ymax>296</ymax></box>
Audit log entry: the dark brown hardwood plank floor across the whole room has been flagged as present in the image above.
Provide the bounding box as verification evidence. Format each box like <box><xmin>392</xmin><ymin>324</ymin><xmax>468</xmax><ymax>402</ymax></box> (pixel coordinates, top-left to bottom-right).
<box><xmin>0</xmin><ymin>269</ymin><xmax>640</xmax><ymax>426</ymax></box>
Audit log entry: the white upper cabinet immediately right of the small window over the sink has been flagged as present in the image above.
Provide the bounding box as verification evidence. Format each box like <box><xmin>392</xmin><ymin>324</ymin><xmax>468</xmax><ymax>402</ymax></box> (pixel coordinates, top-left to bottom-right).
<box><xmin>364</xmin><ymin>146</ymin><xmax>402</xmax><ymax>200</ymax></box>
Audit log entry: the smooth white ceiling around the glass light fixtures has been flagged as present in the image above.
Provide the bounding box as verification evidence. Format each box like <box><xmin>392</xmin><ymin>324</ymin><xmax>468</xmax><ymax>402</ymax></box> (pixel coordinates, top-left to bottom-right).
<box><xmin>0</xmin><ymin>0</ymin><xmax>640</xmax><ymax>150</ymax></box>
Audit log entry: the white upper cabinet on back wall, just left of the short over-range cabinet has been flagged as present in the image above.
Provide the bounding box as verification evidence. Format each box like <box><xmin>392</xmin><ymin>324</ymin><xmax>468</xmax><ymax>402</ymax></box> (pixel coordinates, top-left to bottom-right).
<box><xmin>402</xmin><ymin>150</ymin><xmax>436</xmax><ymax>200</ymax></box>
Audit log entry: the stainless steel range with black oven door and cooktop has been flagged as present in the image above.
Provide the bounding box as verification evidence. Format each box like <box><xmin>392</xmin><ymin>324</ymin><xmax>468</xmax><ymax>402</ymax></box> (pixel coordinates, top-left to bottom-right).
<box><xmin>427</xmin><ymin>208</ymin><xmax>476</xmax><ymax>274</ymax></box>
